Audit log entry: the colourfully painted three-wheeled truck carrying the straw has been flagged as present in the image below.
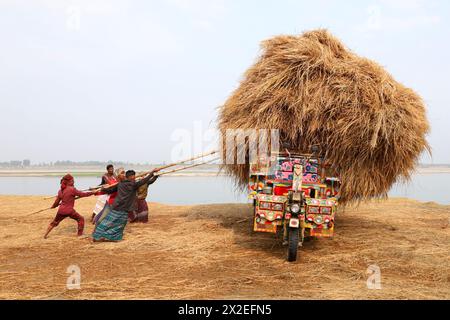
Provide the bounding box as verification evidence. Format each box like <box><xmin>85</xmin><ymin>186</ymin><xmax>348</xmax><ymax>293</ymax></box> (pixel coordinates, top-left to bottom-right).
<box><xmin>249</xmin><ymin>151</ymin><xmax>340</xmax><ymax>262</ymax></box>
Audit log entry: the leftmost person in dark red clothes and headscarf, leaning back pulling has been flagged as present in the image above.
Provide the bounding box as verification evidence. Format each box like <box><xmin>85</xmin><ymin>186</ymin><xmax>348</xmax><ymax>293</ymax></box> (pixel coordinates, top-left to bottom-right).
<box><xmin>44</xmin><ymin>174</ymin><xmax>95</xmax><ymax>239</ymax></box>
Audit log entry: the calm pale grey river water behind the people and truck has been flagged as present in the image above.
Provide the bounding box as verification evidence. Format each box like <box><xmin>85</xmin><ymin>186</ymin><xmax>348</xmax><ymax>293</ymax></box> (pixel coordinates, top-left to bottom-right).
<box><xmin>0</xmin><ymin>173</ymin><xmax>450</xmax><ymax>205</ymax></box>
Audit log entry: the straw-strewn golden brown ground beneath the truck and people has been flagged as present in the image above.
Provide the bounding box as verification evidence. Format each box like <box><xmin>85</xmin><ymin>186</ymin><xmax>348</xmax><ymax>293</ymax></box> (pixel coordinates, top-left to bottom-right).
<box><xmin>0</xmin><ymin>196</ymin><xmax>450</xmax><ymax>299</ymax></box>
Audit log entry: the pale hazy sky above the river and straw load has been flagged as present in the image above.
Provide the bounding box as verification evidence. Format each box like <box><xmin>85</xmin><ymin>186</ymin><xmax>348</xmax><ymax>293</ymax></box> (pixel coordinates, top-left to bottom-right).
<box><xmin>0</xmin><ymin>0</ymin><xmax>450</xmax><ymax>163</ymax></box>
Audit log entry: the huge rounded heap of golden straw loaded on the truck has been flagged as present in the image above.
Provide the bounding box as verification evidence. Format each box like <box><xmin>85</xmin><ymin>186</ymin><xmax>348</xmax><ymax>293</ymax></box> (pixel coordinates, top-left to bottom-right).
<box><xmin>218</xmin><ymin>30</ymin><xmax>429</xmax><ymax>203</ymax></box>
